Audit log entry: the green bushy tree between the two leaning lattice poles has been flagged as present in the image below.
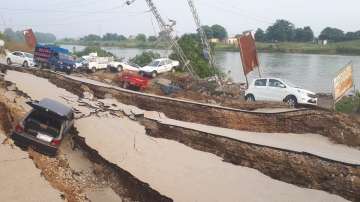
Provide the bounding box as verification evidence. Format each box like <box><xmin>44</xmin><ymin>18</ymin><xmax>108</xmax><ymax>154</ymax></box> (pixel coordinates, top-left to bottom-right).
<box><xmin>170</xmin><ymin>34</ymin><xmax>221</xmax><ymax>78</ymax></box>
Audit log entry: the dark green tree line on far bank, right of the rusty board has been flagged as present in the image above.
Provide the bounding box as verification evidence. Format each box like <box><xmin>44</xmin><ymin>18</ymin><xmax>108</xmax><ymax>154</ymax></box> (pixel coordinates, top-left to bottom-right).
<box><xmin>255</xmin><ymin>20</ymin><xmax>360</xmax><ymax>42</ymax></box>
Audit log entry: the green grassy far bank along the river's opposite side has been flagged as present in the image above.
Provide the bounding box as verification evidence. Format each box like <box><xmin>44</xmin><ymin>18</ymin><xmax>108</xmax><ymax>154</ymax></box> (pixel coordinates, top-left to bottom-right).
<box><xmin>57</xmin><ymin>40</ymin><xmax>360</xmax><ymax>55</ymax></box>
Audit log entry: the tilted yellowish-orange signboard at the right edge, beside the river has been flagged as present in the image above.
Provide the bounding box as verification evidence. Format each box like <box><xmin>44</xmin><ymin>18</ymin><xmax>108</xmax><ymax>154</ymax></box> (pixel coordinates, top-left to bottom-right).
<box><xmin>334</xmin><ymin>64</ymin><xmax>354</xmax><ymax>101</ymax></box>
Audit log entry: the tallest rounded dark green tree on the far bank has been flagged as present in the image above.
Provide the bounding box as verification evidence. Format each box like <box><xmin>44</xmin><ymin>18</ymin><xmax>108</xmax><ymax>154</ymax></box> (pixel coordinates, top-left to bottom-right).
<box><xmin>266</xmin><ymin>20</ymin><xmax>295</xmax><ymax>42</ymax></box>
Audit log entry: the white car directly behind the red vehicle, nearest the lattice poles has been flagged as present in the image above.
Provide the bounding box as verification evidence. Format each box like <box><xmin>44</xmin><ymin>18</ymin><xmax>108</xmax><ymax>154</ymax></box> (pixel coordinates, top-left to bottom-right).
<box><xmin>139</xmin><ymin>58</ymin><xmax>180</xmax><ymax>78</ymax></box>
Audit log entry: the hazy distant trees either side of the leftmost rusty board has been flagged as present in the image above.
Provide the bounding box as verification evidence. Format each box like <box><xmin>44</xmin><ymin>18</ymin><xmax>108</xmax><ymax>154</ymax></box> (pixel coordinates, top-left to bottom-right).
<box><xmin>3</xmin><ymin>28</ymin><xmax>56</xmax><ymax>43</ymax></box>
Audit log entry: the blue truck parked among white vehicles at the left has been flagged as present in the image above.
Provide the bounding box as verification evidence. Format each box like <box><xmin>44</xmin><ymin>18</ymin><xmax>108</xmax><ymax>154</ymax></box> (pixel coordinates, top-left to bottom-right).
<box><xmin>34</xmin><ymin>44</ymin><xmax>75</xmax><ymax>74</ymax></box>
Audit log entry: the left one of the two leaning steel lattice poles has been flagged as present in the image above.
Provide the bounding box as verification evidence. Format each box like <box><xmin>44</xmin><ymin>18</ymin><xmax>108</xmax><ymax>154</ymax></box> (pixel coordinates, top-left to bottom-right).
<box><xmin>126</xmin><ymin>0</ymin><xmax>197</xmax><ymax>78</ymax></box>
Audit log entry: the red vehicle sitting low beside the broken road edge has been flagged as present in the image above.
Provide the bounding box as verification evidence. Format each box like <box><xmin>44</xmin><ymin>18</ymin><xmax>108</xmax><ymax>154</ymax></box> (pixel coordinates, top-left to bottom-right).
<box><xmin>118</xmin><ymin>71</ymin><xmax>149</xmax><ymax>91</ymax></box>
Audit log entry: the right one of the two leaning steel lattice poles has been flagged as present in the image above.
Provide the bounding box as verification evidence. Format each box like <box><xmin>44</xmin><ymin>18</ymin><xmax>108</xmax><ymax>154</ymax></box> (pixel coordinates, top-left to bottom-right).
<box><xmin>187</xmin><ymin>0</ymin><xmax>217</xmax><ymax>75</ymax></box>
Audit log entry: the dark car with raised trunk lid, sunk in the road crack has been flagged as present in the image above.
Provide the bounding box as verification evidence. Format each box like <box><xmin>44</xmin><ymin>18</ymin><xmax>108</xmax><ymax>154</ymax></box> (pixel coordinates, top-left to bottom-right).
<box><xmin>11</xmin><ymin>99</ymin><xmax>74</xmax><ymax>155</ymax></box>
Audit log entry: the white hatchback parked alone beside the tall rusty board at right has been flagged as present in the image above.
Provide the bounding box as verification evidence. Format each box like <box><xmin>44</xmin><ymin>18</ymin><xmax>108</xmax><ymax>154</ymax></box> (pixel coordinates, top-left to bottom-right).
<box><xmin>245</xmin><ymin>78</ymin><xmax>318</xmax><ymax>106</ymax></box>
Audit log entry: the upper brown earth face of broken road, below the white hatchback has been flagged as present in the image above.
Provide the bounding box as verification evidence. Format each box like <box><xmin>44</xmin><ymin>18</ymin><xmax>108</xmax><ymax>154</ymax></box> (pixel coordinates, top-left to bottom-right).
<box><xmin>2</xmin><ymin>66</ymin><xmax>360</xmax><ymax>147</ymax></box>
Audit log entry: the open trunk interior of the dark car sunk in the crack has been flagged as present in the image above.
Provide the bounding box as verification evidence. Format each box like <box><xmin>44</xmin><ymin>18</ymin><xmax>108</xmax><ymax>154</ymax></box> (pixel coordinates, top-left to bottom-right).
<box><xmin>25</xmin><ymin>110</ymin><xmax>62</xmax><ymax>138</ymax></box>
